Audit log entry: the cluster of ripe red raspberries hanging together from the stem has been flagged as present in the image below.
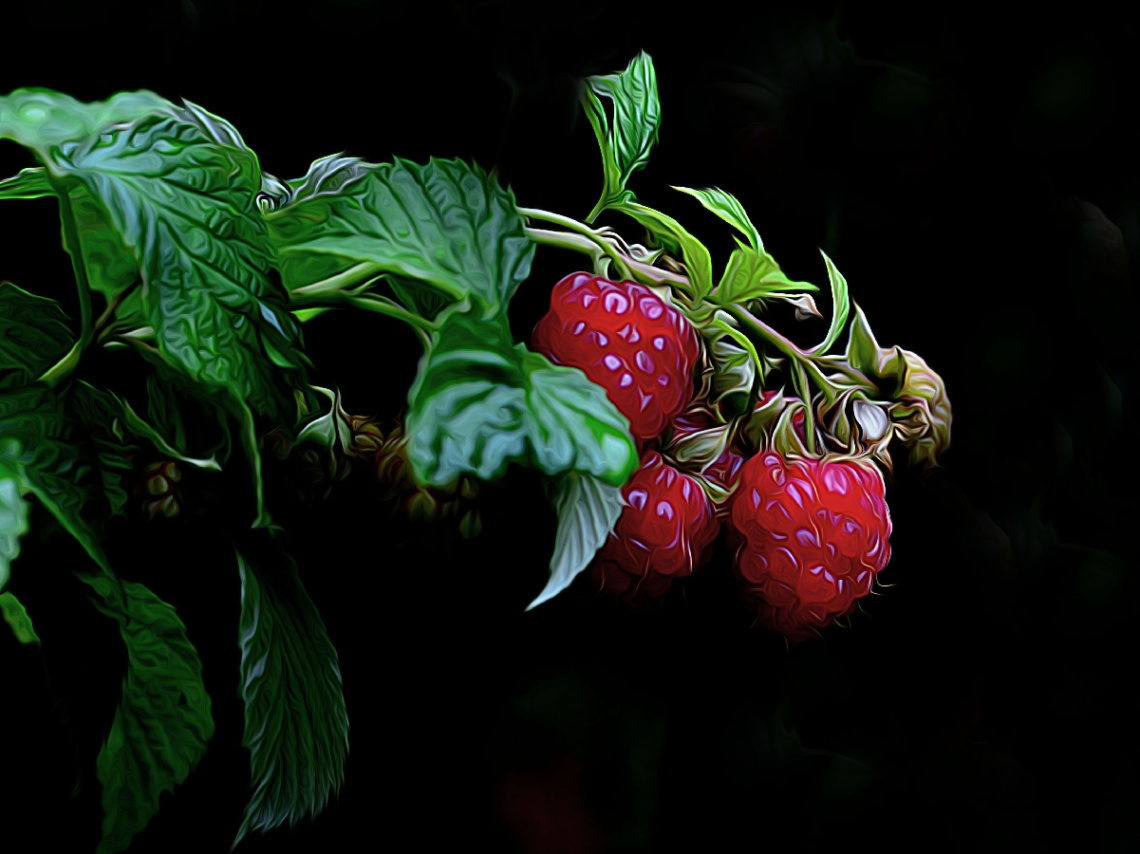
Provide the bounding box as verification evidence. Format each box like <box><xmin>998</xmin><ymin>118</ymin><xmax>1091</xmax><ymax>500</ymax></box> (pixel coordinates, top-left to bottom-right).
<box><xmin>531</xmin><ymin>273</ymin><xmax>890</xmax><ymax>642</ymax></box>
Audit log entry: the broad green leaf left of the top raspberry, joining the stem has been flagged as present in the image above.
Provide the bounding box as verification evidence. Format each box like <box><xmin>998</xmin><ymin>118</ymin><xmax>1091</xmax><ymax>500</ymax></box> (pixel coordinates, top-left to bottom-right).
<box><xmin>264</xmin><ymin>156</ymin><xmax>535</xmax><ymax>312</ymax></box>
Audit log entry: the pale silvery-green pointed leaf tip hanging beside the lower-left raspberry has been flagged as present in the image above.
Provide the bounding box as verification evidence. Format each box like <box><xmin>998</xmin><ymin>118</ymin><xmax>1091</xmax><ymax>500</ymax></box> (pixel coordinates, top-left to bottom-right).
<box><xmin>527</xmin><ymin>472</ymin><xmax>625</xmax><ymax>611</ymax></box>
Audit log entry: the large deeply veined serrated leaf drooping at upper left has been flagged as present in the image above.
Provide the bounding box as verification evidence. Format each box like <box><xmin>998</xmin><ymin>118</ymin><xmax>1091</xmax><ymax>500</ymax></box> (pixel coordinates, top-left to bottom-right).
<box><xmin>61</xmin><ymin>105</ymin><xmax>304</xmax><ymax>423</ymax></box>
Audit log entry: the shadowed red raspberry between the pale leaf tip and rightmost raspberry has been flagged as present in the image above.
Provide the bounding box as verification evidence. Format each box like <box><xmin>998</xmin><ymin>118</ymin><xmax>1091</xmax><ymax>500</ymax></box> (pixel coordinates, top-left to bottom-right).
<box><xmin>591</xmin><ymin>450</ymin><xmax>720</xmax><ymax>601</ymax></box>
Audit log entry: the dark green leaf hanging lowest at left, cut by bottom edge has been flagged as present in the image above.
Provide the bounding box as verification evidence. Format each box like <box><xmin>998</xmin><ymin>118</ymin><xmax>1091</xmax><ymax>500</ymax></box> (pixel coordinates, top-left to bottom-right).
<box><xmin>80</xmin><ymin>562</ymin><xmax>214</xmax><ymax>854</ymax></box>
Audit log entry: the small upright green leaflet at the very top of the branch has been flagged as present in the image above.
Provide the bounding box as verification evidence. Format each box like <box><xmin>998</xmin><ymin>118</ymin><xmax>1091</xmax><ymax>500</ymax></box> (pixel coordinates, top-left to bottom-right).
<box><xmin>581</xmin><ymin>51</ymin><xmax>661</xmax><ymax>223</ymax></box>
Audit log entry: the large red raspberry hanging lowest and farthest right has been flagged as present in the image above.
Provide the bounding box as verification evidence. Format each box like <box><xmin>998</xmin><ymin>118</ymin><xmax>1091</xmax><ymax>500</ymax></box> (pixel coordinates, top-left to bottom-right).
<box><xmin>730</xmin><ymin>450</ymin><xmax>890</xmax><ymax>641</ymax></box>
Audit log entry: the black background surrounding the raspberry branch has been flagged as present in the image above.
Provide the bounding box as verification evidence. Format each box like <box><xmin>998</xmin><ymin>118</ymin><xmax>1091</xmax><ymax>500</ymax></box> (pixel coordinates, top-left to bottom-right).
<box><xmin>0</xmin><ymin>0</ymin><xmax>1140</xmax><ymax>854</ymax></box>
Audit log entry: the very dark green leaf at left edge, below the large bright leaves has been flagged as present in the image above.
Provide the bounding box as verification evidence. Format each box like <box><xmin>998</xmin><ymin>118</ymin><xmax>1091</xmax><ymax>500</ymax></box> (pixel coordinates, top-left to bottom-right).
<box><xmin>0</xmin><ymin>282</ymin><xmax>74</xmax><ymax>389</ymax></box>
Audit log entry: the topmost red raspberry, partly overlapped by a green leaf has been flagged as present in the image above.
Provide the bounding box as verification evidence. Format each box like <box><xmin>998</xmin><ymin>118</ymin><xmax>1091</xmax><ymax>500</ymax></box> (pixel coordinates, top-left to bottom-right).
<box><xmin>531</xmin><ymin>273</ymin><xmax>700</xmax><ymax>442</ymax></box>
